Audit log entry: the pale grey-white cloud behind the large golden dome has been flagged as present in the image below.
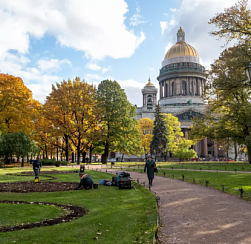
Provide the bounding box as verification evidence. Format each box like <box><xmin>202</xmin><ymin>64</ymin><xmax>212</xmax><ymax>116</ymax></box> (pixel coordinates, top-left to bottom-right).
<box><xmin>164</xmin><ymin>0</ymin><xmax>240</xmax><ymax>66</ymax></box>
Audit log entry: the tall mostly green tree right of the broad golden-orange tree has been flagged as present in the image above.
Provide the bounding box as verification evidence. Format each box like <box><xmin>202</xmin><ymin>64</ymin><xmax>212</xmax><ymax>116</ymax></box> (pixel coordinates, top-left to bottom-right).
<box><xmin>97</xmin><ymin>80</ymin><xmax>139</xmax><ymax>163</ymax></box>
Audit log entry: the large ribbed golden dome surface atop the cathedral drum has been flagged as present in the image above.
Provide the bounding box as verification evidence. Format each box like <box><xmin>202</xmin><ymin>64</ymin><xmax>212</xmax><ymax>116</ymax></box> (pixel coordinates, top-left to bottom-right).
<box><xmin>165</xmin><ymin>42</ymin><xmax>199</xmax><ymax>59</ymax></box>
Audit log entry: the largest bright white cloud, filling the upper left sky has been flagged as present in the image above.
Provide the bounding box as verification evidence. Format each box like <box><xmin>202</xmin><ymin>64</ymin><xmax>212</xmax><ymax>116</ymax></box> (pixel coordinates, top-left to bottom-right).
<box><xmin>0</xmin><ymin>0</ymin><xmax>145</xmax><ymax>59</ymax></box>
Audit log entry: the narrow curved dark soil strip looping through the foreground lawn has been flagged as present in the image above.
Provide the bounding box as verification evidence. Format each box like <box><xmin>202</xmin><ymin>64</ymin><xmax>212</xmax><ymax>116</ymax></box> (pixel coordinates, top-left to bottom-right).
<box><xmin>0</xmin><ymin>200</ymin><xmax>87</xmax><ymax>233</ymax></box>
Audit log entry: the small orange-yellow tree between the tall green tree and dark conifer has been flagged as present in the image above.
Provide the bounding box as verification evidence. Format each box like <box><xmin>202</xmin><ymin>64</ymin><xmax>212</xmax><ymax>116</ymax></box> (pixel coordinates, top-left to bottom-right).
<box><xmin>138</xmin><ymin>118</ymin><xmax>153</xmax><ymax>158</ymax></box>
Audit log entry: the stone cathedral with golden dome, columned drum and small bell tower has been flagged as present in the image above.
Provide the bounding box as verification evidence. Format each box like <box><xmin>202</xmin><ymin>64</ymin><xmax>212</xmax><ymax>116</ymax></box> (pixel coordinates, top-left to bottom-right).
<box><xmin>136</xmin><ymin>27</ymin><xmax>223</xmax><ymax>159</ymax></box>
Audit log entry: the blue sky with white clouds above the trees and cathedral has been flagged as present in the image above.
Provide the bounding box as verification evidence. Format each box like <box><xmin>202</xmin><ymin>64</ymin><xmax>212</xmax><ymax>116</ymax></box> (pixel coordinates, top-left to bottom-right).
<box><xmin>0</xmin><ymin>0</ymin><xmax>244</xmax><ymax>107</ymax></box>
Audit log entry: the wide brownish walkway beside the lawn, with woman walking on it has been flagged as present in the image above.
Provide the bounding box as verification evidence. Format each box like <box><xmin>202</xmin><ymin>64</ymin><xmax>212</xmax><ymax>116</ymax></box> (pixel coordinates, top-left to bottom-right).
<box><xmin>86</xmin><ymin>166</ymin><xmax>251</xmax><ymax>244</ymax></box>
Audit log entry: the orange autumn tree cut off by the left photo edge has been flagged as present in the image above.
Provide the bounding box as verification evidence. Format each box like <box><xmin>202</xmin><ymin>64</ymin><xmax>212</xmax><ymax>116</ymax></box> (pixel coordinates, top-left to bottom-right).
<box><xmin>0</xmin><ymin>73</ymin><xmax>34</xmax><ymax>134</ymax></box>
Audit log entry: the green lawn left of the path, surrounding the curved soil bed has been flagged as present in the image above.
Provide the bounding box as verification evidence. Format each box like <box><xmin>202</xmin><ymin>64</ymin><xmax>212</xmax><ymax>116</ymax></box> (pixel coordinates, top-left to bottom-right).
<box><xmin>0</xmin><ymin>167</ymin><xmax>157</xmax><ymax>244</ymax></box>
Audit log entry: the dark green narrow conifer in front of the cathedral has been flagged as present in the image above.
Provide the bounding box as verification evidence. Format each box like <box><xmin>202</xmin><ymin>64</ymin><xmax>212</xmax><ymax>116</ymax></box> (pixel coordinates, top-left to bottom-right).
<box><xmin>150</xmin><ymin>104</ymin><xmax>168</xmax><ymax>160</ymax></box>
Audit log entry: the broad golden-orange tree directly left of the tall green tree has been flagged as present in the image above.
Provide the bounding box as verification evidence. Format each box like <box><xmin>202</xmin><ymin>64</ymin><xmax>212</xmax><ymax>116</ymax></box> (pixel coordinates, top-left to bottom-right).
<box><xmin>44</xmin><ymin>77</ymin><xmax>100</xmax><ymax>164</ymax></box>
